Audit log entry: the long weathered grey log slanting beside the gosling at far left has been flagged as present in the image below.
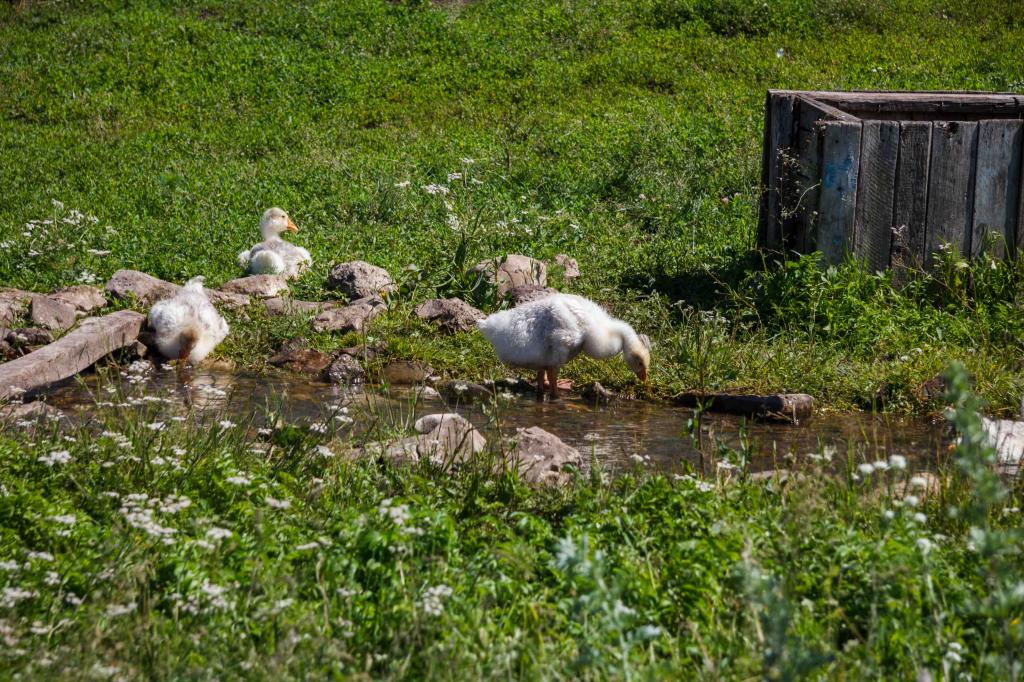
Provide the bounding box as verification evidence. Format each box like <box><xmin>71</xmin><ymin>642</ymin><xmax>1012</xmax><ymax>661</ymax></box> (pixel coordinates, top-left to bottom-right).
<box><xmin>0</xmin><ymin>310</ymin><xmax>145</xmax><ymax>399</ymax></box>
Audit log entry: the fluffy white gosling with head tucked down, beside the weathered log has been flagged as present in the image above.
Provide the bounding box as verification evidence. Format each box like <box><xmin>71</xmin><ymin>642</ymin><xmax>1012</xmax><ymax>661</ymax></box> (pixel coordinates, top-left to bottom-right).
<box><xmin>150</xmin><ymin>276</ymin><xmax>228</xmax><ymax>363</ymax></box>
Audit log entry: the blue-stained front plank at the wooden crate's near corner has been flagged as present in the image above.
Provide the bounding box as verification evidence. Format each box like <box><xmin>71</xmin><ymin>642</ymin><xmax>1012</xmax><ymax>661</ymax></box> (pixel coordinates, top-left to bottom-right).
<box><xmin>816</xmin><ymin>121</ymin><xmax>860</xmax><ymax>264</ymax></box>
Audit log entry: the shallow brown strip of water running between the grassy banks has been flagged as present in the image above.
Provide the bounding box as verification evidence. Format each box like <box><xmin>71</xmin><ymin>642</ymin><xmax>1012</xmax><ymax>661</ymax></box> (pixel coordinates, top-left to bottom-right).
<box><xmin>45</xmin><ymin>369</ymin><xmax>949</xmax><ymax>471</ymax></box>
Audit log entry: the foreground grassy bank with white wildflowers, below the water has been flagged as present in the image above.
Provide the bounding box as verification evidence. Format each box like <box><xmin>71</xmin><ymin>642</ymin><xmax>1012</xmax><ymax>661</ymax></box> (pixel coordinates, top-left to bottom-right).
<box><xmin>0</xmin><ymin>360</ymin><xmax>1024</xmax><ymax>680</ymax></box>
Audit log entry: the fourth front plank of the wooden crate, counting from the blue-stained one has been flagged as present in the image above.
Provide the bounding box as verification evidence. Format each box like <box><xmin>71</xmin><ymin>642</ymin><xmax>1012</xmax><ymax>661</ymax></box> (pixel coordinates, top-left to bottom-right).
<box><xmin>926</xmin><ymin>121</ymin><xmax>978</xmax><ymax>263</ymax></box>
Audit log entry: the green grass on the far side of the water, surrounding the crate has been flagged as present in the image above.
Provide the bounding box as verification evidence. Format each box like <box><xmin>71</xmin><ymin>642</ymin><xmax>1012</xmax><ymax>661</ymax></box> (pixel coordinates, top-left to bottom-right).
<box><xmin>6</xmin><ymin>0</ymin><xmax>1024</xmax><ymax>412</ymax></box>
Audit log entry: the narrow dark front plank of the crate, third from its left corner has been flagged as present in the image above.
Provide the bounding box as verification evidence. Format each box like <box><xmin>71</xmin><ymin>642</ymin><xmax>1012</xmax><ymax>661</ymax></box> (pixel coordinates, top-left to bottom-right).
<box><xmin>890</xmin><ymin>122</ymin><xmax>932</xmax><ymax>279</ymax></box>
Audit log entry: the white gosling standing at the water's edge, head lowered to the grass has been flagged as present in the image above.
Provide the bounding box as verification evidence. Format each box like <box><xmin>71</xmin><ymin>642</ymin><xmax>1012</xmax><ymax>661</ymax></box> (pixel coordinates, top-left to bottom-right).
<box><xmin>476</xmin><ymin>294</ymin><xmax>650</xmax><ymax>399</ymax></box>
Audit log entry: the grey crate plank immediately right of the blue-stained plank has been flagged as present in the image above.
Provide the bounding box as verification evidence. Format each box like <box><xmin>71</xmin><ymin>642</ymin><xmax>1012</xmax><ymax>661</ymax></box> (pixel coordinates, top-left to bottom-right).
<box><xmin>853</xmin><ymin>121</ymin><xmax>899</xmax><ymax>272</ymax></box>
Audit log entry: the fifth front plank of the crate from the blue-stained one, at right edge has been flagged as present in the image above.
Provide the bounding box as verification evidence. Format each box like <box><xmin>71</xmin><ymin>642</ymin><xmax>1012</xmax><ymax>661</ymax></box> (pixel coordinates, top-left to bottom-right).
<box><xmin>971</xmin><ymin>120</ymin><xmax>1024</xmax><ymax>258</ymax></box>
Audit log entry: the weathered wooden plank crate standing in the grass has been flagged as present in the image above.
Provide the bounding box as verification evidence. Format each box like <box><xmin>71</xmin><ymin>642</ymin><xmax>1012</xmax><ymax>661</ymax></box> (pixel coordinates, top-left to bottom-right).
<box><xmin>758</xmin><ymin>90</ymin><xmax>1024</xmax><ymax>270</ymax></box>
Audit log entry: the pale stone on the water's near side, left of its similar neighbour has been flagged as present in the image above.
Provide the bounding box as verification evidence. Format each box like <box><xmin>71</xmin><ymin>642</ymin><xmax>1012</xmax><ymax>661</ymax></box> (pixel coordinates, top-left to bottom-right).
<box><xmin>362</xmin><ymin>414</ymin><xmax>486</xmax><ymax>466</ymax></box>
